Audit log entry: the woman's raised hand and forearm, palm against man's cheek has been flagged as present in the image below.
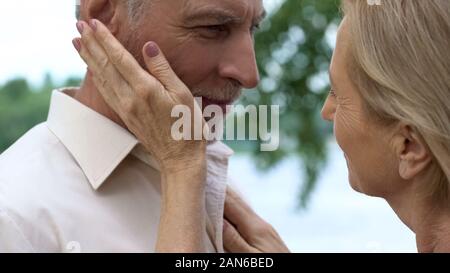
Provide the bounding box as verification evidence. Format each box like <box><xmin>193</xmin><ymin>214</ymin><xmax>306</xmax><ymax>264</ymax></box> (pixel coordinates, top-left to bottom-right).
<box><xmin>73</xmin><ymin>20</ymin><xmax>206</xmax><ymax>252</ymax></box>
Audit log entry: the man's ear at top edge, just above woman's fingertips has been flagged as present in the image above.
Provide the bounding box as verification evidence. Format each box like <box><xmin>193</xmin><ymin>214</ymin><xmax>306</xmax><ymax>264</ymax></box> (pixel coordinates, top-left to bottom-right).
<box><xmin>81</xmin><ymin>0</ymin><xmax>119</xmax><ymax>34</ymax></box>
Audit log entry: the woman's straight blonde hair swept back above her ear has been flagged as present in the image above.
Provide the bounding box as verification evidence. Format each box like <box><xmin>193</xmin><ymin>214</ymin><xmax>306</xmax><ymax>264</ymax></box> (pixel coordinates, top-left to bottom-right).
<box><xmin>342</xmin><ymin>0</ymin><xmax>450</xmax><ymax>201</ymax></box>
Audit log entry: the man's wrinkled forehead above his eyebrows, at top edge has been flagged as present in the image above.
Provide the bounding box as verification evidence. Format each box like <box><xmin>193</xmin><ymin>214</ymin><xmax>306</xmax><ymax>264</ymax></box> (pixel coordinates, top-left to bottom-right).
<box><xmin>179</xmin><ymin>0</ymin><xmax>266</xmax><ymax>23</ymax></box>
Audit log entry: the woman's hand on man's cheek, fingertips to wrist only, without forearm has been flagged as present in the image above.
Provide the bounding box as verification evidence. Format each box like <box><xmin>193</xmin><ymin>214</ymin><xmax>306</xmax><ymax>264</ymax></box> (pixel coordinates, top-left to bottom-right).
<box><xmin>74</xmin><ymin>19</ymin><xmax>206</xmax><ymax>173</ymax></box>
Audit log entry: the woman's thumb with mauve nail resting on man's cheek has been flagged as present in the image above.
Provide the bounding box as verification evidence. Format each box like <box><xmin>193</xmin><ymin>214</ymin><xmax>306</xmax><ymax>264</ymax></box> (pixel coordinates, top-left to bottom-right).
<box><xmin>143</xmin><ymin>42</ymin><xmax>185</xmax><ymax>91</ymax></box>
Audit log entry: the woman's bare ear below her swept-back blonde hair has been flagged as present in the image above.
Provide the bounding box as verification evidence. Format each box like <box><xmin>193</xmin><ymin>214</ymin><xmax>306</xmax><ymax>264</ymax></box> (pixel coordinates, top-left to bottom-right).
<box><xmin>393</xmin><ymin>124</ymin><xmax>432</xmax><ymax>180</ymax></box>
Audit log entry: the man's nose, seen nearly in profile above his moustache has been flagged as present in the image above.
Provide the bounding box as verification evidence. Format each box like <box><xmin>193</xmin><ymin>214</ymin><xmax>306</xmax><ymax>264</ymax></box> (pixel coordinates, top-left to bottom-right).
<box><xmin>219</xmin><ymin>35</ymin><xmax>259</xmax><ymax>89</ymax></box>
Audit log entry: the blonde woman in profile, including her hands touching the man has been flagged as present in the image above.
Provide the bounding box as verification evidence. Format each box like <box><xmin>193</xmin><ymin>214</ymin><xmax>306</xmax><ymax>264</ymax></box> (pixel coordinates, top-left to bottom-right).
<box><xmin>77</xmin><ymin>0</ymin><xmax>450</xmax><ymax>252</ymax></box>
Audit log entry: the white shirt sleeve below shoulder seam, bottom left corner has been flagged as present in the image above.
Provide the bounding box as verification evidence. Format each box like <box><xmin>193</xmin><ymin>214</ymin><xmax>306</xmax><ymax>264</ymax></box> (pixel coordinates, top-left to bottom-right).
<box><xmin>0</xmin><ymin>208</ymin><xmax>35</xmax><ymax>253</ymax></box>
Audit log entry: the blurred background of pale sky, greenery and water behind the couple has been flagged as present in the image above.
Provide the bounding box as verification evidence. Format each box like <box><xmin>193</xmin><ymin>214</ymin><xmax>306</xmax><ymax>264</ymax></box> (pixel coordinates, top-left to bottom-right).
<box><xmin>0</xmin><ymin>0</ymin><xmax>416</xmax><ymax>252</ymax></box>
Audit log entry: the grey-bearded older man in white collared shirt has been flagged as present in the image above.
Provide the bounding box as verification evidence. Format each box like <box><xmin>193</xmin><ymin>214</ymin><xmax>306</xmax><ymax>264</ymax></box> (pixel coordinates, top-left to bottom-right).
<box><xmin>0</xmin><ymin>0</ymin><xmax>264</xmax><ymax>252</ymax></box>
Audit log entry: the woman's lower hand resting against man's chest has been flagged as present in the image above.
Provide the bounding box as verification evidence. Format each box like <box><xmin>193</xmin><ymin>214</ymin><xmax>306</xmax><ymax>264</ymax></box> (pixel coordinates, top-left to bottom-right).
<box><xmin>223</xmin><ymin>189</ymin><xmax>289</xmax><ymax>253</ymax></box>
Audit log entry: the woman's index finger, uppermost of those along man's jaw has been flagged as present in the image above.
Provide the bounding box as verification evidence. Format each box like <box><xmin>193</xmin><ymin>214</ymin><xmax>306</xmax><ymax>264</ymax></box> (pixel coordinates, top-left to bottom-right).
<box><xmin>90</xmin><ymin>19</ymin><xmax>151</xmax><ymax>90</ymax></box>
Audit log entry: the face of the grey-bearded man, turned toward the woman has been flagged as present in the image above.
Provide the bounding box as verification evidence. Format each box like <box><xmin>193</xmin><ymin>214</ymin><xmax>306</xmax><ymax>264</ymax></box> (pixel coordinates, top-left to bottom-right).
<box><xmin>118</xmin><ymin>0</ymin><xmax>264</xmax><ymax>110</ymax></box>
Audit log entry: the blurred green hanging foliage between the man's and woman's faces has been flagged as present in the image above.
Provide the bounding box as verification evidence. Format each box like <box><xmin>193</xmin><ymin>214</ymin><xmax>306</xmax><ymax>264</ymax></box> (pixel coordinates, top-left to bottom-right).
<box><xmin>232</xmin><ymin>0</ymin><xmax>340</xmax><ymax>207</ymax></box>
